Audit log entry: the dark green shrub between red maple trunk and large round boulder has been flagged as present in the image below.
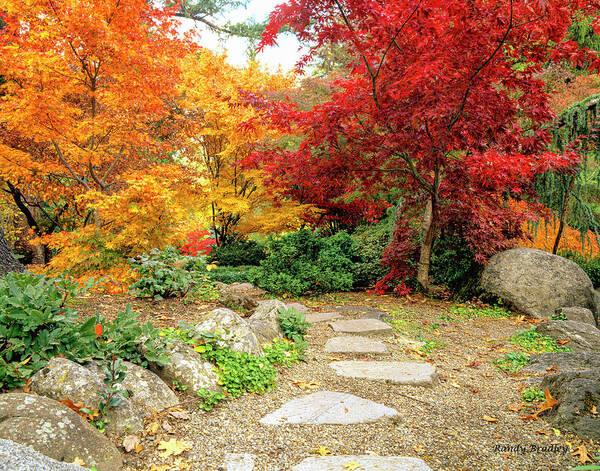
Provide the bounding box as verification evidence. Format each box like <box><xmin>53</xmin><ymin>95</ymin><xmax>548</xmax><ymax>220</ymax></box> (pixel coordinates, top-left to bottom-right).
<box><xmin>430</xmin><ymin>234</ymin><xmax>483</xmax><ymax>299</ymax></box>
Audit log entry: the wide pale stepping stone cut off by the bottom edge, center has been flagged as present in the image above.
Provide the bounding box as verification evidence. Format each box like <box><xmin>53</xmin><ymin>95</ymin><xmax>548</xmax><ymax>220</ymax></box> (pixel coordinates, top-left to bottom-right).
<box><xmin>292</xmin><ymin>455</ymin><xmax>431</xmax><ymax>471</ymax></box>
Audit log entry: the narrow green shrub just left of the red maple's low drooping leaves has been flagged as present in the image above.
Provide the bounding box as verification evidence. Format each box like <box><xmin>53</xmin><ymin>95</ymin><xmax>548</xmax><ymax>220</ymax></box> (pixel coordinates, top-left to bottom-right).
<box><xmin>352</xmin><ymin>221</ymin><xmax>393</xmax><ymax>287</ymax></box>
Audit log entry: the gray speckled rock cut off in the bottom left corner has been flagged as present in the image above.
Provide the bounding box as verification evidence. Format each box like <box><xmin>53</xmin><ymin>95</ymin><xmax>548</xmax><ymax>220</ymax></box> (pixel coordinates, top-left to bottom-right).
<box><xmin>0</xmin><ymin>439</ymin><xmax>86</xmax><ymax>471</ymax></box>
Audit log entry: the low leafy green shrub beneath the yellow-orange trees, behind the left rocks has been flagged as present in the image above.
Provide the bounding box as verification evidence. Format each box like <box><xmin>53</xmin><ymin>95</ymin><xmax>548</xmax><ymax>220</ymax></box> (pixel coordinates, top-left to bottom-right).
<box><xmin>129</xmin><ymin>247</ymin><xmax>208</xmax><ymax>299</ymax></box>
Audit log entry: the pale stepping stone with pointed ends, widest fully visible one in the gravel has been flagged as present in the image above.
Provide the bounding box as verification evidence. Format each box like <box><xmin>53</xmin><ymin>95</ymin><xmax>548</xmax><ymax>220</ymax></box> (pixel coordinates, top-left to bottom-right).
<box><xmin>260</xmin><ymin>391</ymin><xmax>398</xmax><ymax>425</ymax></box>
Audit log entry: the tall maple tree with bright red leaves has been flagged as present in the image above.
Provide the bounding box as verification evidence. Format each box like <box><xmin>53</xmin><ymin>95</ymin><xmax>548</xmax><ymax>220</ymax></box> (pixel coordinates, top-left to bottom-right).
<box><xmin>254</xmin><ymin>0</ymin><xmax>600</xmax><ymax>289</ymax></box>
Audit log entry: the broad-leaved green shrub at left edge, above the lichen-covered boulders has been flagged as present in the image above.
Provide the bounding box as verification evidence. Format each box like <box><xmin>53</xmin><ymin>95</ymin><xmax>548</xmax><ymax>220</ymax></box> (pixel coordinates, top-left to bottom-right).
<box><xmin>0</xmin><ymin>273</ymin><xmax>96</xmax><ymax>388</ymax></box>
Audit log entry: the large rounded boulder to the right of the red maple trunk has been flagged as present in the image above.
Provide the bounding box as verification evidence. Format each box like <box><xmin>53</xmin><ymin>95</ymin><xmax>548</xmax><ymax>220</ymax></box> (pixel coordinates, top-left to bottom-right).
<box><xmin>480</xmin><ymin>247</ymin><xmax>597</xmax><ymax>318</ymax></box>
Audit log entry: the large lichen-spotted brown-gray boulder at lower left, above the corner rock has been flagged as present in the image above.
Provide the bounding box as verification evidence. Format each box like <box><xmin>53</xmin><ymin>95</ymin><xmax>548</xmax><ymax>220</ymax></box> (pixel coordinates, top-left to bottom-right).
<box><xmin>0</xmin><ymin>393</ymin><xmax>123</xmax><ymax>471</ymax></box>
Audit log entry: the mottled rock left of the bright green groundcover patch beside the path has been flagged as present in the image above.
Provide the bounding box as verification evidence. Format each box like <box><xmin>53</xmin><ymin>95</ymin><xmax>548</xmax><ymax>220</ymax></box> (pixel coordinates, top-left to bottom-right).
<box><xmin>142</xmin><ymin>340</ymin><xmax>221</xmax><ymax>395</ymax></box>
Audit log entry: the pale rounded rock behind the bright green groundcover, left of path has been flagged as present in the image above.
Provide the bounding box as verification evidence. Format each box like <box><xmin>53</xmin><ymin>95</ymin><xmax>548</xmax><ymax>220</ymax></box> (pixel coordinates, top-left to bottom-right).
<box><xmin>194</xmin><ymin>308</ymin><xmax>263</xmax><ymax>356</ymax></box>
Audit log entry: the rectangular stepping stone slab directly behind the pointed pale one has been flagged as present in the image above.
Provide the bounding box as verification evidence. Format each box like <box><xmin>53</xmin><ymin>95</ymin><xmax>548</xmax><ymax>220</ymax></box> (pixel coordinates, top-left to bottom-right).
<box><xmin>329</xmin><ymin>360</ymin><xmax>438</xmax><ymax>386</ymax></box>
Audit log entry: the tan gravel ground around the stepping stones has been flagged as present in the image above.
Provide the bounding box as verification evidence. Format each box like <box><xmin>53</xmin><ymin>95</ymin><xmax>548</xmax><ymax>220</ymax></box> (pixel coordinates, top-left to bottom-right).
<box><xmin>77</xmin><ymin>293</ymin><xmax>598</xmax><ymax>471</ymax></box>
